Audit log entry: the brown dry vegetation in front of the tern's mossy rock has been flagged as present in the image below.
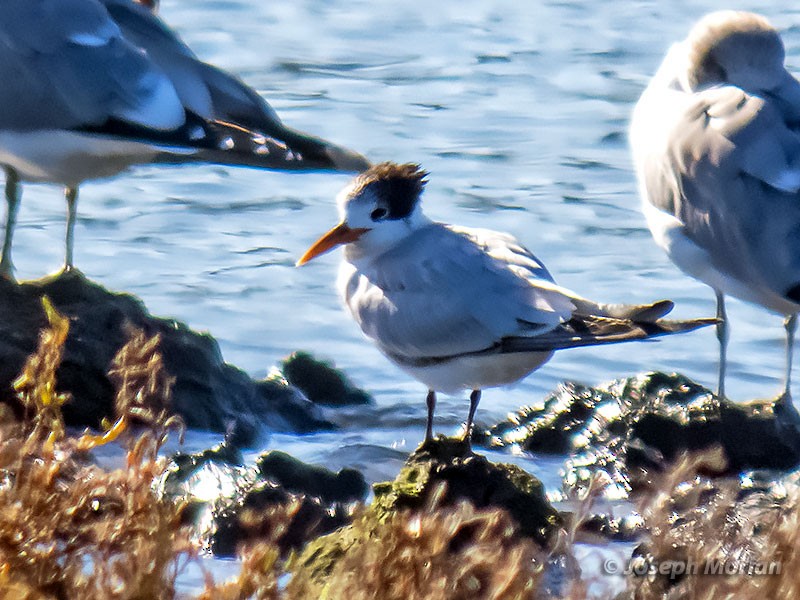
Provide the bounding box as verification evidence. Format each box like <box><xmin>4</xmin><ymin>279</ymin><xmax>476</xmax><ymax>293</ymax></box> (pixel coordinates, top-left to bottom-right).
<box><xmin>287</xmin><ymin>486</ymin><xmax>546</xmax><ymax>600</ymax></box>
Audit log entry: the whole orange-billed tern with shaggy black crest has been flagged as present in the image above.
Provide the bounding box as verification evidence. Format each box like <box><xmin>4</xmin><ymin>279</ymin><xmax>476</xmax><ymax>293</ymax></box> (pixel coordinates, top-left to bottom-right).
<box><xmin>297</xmin><ymin>163</ymin><xmax>715</xmax><ymax>441</ymax></box>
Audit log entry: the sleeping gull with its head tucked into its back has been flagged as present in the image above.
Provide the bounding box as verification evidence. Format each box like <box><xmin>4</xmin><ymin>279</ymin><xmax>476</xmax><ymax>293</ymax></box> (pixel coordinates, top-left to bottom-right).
<box><xmin>630</xmin><ymin>11</ymin><xmax>800</xmax><ymax>400</ymax></box>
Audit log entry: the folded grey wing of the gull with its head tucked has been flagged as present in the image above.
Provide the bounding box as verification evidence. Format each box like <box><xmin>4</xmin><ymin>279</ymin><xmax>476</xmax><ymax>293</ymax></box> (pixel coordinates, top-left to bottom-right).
<box><xmin>634</xmin><ymin>80</ymin><xmax>800</xmax><ymax>296</ymax></box>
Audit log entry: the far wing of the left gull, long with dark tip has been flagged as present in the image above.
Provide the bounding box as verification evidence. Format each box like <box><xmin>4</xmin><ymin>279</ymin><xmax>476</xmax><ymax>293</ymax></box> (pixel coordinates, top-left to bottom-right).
<box><xmin>101</xmin><ymin>0</ymin><xmax>369</xmax><ymax>171</ymax></box>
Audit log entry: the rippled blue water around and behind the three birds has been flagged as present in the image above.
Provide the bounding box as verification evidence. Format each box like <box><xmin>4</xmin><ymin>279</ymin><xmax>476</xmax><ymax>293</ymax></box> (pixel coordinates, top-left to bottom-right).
<box><xmin>10</xmin><ymin>0</ymin><xmax>800</xmax><ymax>584</ymax></box>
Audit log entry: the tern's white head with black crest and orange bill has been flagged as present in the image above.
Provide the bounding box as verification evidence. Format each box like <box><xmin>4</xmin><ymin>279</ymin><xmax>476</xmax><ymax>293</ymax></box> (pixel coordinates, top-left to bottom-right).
<box><xmin>297</xmin><ymin>162</ymin><xmax>430</xmax><ymax>266</ymax></box>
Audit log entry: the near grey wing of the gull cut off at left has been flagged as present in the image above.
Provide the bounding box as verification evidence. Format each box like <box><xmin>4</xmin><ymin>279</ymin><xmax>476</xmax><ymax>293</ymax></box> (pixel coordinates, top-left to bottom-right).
<box><xmin>0</xmin><ymin>0</ymin><xmax>185</xmax><ymax>131</ymax></box>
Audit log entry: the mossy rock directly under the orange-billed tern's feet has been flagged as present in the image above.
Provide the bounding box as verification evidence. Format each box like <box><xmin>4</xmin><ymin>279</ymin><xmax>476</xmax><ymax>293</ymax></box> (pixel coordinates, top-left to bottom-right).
<box><xmin>292</xmin><ymin>437</ymin><xmax>561</xmax><ymax>589</ymax></box>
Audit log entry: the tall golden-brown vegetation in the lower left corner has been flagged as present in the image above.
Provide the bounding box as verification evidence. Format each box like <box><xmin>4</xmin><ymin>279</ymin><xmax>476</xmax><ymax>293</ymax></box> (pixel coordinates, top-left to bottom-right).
<box><xmin>0</xmin><ymin>300</ymin><xmax>194</xmax><ymax>600</ymax></box>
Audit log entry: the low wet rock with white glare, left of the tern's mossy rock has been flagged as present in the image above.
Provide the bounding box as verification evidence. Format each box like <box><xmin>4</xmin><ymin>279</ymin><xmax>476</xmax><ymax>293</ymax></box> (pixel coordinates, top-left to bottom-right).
<box><xmin>160</xmin><ymin>444</ymin><xmax>367</xmax><ymax>556</ymax></box>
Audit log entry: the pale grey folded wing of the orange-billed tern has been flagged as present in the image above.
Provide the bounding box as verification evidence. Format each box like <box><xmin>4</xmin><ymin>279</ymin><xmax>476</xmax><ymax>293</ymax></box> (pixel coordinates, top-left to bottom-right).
<box><xmin>342</xmin><ymin>224</ymin><xmax>574</xmax><ymax>358</ymax></box>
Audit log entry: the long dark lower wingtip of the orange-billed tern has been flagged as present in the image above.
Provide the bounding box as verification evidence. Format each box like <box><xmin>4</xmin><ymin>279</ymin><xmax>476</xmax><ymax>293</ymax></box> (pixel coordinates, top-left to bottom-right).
<box><xmin>502</xmin><ymin>312</ymin><xmax>718</xmax><ymax>352</ymax></box>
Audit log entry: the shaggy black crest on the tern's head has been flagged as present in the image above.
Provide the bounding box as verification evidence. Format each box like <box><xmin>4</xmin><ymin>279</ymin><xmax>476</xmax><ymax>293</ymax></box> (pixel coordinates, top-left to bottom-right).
<box><xmin>353</xmin><ymin>162</ymin><xmax>428</xmax><ymax>220</ymax></box>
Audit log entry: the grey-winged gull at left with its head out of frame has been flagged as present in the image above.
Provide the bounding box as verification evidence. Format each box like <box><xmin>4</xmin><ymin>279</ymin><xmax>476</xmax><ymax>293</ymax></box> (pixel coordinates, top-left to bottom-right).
<box><xmin>0</xmin><ymin>0</ymin><xmax>369</xmax><ymax>278</ymax></box>
